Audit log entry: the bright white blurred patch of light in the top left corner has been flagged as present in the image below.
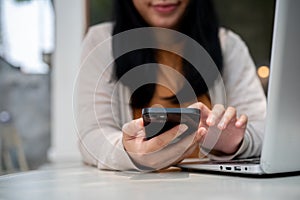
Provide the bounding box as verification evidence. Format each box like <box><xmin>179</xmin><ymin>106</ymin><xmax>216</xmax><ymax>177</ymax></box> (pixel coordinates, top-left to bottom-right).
<box><xmin>0</xmin><ymin>0</ymin><xmax>54</xmax><ymax>73</ymax></box>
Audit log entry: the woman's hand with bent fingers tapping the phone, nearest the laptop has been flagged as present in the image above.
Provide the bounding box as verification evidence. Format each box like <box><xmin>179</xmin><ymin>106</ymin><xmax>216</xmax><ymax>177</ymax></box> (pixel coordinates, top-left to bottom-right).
<box><xmin>189</xmin><ymin>102</ymin><xmax>248</xmax><ymax>154</ymax></box>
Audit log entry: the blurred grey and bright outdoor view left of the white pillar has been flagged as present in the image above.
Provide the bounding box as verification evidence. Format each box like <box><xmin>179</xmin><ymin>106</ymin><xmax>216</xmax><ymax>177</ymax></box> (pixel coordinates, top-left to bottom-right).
<box><xmin>0</xmin><ymin>0</ymin><xmax>52</xmax><ymax>174</ymax></box>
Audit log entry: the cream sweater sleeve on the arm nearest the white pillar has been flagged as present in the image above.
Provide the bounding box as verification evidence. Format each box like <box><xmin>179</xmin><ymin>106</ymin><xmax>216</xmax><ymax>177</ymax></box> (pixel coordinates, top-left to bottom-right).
<box><xmin>74</xmin><ymin>24</ymin><xmax>144</xmax><ymax>171</ymax></box>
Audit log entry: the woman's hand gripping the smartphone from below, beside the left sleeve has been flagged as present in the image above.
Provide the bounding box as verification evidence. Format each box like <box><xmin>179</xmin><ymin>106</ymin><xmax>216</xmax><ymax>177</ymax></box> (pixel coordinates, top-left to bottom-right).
<box><xmin>122</xmin><ymin>118</ymin><xmax>205</xmax><ymax>170</ymax></box>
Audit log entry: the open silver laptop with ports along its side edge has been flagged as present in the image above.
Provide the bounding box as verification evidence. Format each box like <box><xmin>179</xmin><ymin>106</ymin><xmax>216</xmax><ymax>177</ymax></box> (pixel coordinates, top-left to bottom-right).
<box><xmin>179</xmin><ymin>0</ymin><xmax>300</xmax><ymax>175</ymax></box>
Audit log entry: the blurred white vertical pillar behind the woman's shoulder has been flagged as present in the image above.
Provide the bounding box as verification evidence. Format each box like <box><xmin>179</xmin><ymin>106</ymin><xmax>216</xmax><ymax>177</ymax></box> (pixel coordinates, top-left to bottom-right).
<box><xmin>49</xmin><ymin>0</ymin><xmax>86</xmax><ymax>162</ymax></box>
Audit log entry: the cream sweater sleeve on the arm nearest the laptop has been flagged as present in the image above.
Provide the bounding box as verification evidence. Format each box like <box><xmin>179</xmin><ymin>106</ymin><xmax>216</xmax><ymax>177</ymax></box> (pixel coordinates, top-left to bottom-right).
<box><xmin>205</xmin><ymin>29</ymin><xmax>266</xmax><ymax>160</ymax></box>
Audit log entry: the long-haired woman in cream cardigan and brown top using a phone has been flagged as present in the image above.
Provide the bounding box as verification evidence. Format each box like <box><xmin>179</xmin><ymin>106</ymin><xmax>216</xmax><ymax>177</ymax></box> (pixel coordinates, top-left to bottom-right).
<box><xmin>77</xmin><ymin>0</ymin><xmax>266</xmax><ymax>171</ymax></box>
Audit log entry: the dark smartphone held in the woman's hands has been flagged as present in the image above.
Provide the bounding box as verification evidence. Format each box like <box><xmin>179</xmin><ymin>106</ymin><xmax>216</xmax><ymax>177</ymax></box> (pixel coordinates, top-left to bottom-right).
<box><xmin>142</xmin><ymin>108</ymin><xmax>200</xmax><ymax>140</ymax></box>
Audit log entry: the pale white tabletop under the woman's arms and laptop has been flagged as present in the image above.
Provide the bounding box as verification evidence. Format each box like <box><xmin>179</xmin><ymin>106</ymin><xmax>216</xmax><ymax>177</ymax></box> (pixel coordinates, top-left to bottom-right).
<box><xmin>0</xmin><ymin>164</ymin><xmax>300</xmax><ymax>200</ymax></box>
